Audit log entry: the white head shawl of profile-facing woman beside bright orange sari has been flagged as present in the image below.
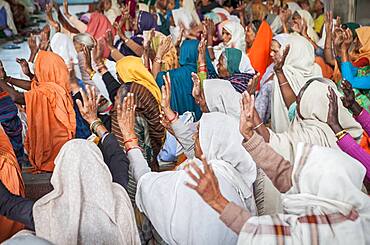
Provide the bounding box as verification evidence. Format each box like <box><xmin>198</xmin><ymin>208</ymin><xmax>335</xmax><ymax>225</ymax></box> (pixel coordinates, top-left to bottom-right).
<box><xmin>271</xmin><ymin>34</ymin><xmax>322</xmax><ymax>133</ymax></box>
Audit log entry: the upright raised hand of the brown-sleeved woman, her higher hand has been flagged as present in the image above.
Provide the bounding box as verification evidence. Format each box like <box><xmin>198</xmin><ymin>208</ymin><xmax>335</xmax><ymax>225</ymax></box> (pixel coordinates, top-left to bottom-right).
<box><xmin>239</xmin><ymin>92</ymin><xmax>254</xmax><ymax>139</ymax></box>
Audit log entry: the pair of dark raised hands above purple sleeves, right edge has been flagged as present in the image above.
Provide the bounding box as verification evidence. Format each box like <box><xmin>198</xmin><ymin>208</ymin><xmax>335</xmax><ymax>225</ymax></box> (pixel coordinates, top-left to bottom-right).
<box><xmin>327</xmin><ymin>80</ymin><xmax>362</xmax><ymax>133</ymax></box>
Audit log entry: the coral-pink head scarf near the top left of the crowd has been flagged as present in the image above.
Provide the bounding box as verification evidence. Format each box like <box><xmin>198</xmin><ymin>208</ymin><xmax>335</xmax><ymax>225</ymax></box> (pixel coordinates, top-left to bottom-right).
<box><xmin>86</xmin><ymin>12</ymin><xmax>115</xmax><ymax>58</ymax></box>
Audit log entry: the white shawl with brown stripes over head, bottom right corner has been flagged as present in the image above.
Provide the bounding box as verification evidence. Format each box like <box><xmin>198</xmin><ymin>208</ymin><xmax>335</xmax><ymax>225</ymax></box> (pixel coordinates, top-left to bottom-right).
<box><xmin>238</xmin><ymin>143</ymin><xmax>370</xmax><ymax>245</ymax></box>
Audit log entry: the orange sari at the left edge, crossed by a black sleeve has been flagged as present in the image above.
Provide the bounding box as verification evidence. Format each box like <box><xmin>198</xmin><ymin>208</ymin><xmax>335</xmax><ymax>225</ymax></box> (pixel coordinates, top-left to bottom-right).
<box><xmin>0</xmin><ymin>126</ymin><xmax>25</xmax><ymax>243</ymax></box>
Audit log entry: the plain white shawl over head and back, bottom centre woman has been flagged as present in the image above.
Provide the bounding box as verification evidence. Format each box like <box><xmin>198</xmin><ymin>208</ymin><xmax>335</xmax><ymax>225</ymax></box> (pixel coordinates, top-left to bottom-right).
<box><xmin>136</xmin><ymin>112</ymin><xmax>256</xmax><ymax>245</ymax></box>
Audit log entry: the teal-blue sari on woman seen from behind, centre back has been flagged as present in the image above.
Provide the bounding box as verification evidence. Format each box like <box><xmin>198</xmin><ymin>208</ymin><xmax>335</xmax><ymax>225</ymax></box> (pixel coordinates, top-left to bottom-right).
<box><xmin>156</xmin><ymin>40</ymin><xmax>216</xmax><ymax>120</ymax></box>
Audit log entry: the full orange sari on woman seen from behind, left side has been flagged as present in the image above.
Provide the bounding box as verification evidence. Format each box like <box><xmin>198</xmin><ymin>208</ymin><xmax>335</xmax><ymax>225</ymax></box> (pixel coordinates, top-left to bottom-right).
<box><xmin>24</xmin><ymin>51</ymin><xmax>76</xmax><ymax>172</ymax></box>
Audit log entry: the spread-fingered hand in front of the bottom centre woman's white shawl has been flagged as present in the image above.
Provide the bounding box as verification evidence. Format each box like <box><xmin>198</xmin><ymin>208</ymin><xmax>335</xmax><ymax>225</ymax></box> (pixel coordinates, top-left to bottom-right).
<box><xmin>185</xmin><ymin>156</ymin><xmax>229</xmax><ymax>213</ymax></box>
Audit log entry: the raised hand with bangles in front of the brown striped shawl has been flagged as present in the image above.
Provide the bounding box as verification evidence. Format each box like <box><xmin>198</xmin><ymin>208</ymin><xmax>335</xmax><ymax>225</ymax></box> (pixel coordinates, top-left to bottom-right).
<box><xmin>116</xmin><ymin>93</ymin><xmax>136</xmax><ymax>140</ymax></box>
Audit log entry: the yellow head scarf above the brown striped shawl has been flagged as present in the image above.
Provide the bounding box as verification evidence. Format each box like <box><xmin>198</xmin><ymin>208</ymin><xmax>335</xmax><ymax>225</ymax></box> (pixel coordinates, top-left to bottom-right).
<box><xmin>116</xmin><ymin>56</ymin><xmax>161</xmax><ymax>104</ymax></box>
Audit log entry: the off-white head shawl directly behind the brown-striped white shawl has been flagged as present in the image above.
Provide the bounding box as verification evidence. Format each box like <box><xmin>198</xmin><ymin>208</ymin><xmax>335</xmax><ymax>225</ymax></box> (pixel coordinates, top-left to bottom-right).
<box><xmin>270</xmin><ymin>80</ymin><xmax>363</xmax><ymax>162</ymax></box>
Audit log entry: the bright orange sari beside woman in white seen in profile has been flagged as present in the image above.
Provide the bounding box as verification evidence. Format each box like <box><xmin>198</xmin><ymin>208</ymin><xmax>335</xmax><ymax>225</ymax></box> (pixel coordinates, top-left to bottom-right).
<box><xmin>248</xmin><ymin>21</ymin><xmax>272</xmax><ymax>89</ymax></box>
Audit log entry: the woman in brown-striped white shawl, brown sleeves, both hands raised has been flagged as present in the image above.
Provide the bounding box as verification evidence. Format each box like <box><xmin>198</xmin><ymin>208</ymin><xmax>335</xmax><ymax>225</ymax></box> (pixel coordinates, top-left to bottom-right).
<box><xmin>189</xmin><ymin>92</ymin><xmax>370</xmax><ymax>245</ymax></box>
